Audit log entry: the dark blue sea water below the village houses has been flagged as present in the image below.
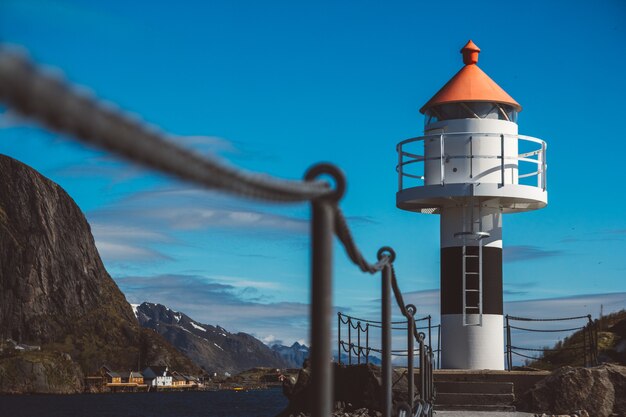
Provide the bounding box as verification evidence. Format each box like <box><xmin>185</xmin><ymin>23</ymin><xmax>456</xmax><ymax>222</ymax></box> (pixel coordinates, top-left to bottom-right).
<box><xmin>0</xmin><ymin>389</ymin><xmax>287</xmax><ymax>417</ymax></box>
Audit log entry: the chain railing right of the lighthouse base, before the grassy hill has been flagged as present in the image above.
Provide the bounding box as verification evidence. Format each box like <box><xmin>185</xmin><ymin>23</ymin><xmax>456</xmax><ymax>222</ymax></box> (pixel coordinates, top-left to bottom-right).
<box><xmin>504</xmin><ymin>314</ymin><xmax>598</xmax><ymax>371</ymax></box>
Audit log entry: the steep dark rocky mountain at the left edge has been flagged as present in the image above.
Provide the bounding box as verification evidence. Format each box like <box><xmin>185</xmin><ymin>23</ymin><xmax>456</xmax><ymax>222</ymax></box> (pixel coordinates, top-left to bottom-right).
<box><xmin>0</xmin><ymin>155</ymin><xmax>197</xmax><ymax>391</ymax></box>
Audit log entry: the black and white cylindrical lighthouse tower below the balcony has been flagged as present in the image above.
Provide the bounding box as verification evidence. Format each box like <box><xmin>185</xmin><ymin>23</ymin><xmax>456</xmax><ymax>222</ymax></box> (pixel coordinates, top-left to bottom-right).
<box><xmin>441</xmin><ymin>208</ymin><xmax>504</xmax><ymax>370</ymax></box>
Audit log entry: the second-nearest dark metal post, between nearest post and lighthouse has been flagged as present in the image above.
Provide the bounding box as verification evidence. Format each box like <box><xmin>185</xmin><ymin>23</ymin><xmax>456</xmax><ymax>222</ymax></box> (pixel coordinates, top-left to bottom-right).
<box><xmin>380</xmin><ymin>264</ymin><xmax>391</xmax><ymax>417</ymax></box>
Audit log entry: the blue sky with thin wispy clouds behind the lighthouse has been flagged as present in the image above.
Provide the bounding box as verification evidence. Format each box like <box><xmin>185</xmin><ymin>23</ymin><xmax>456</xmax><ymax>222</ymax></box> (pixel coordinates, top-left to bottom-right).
<box><xmin>0</xmin><ymin>0</ymin><xmax>626</xmax><ymax>352</ymax></box>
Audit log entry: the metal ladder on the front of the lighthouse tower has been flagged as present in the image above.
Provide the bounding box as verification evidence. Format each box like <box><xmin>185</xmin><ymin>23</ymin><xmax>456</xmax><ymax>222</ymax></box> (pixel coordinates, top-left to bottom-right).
<box><xmin>454</xmin><ymin>202</ymin><xmax>490</xmax><ymax>326</ymax></box>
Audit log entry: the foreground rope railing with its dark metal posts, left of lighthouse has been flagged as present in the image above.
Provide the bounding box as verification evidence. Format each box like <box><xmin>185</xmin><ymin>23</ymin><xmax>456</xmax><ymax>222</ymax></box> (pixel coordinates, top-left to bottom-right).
<box><xmin>0</xmin><ymin>48</ymin><xmax>434</xmax><ymax>417</ymax></box>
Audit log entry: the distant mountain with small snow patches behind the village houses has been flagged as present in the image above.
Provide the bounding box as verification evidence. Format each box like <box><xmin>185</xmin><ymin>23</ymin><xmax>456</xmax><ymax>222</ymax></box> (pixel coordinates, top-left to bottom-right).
<box><xmin>134</xmin><ymin>302</ymin><xmax>288</xmax><ymax>374</ymax></box>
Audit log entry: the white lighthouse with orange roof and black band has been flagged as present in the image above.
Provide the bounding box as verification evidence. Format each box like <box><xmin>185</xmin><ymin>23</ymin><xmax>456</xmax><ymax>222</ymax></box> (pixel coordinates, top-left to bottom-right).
<box><xmin>396</xmin><ymin>40</ymin><xmax>548</xmax><ymax>370</ymax></box>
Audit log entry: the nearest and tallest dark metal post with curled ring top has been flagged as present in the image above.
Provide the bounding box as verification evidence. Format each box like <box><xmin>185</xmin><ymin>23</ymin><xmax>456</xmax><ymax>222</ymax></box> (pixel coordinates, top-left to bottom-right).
<box><xmin>305</xmin><ymin>164</ymin><xmax>345</xmax><ymax>417</ymax></box>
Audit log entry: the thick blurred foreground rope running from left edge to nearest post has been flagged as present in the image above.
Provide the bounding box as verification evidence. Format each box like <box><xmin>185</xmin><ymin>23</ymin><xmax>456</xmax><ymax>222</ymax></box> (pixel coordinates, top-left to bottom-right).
<box><xmin>0</xmin><ymin>49</ymin><xmax>330</xmax><ymax>202</ymax></box>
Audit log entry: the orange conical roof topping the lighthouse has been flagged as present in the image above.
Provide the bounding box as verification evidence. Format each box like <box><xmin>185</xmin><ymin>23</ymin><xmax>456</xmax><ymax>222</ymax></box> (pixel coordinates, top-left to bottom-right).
<box><xmin>420</xmin><ymin>40</ymin><xmax>522</xmax><ymax>113</ymax></box>
